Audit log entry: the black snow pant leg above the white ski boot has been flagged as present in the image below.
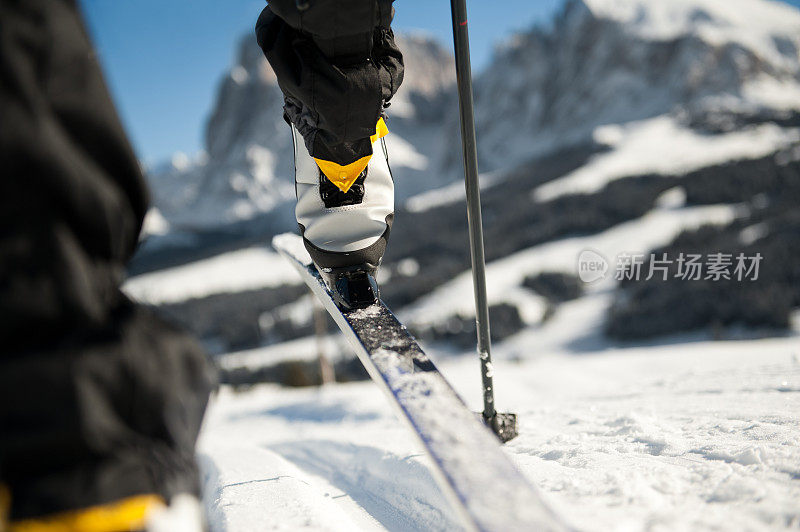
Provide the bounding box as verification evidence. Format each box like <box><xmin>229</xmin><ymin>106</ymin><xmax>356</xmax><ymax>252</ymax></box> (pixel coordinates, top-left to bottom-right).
<box><xmin>256</xmin><ymin>0</ymin><xmax>403</xmax><ymax>165</ymax></box>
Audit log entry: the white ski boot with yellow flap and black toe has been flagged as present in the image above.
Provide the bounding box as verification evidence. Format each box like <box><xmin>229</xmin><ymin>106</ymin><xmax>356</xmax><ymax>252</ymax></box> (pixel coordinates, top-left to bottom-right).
<box><xmin>292</xmin><ymin>119</ymin><xmax>394</xmax><ymax>310</ymax></box>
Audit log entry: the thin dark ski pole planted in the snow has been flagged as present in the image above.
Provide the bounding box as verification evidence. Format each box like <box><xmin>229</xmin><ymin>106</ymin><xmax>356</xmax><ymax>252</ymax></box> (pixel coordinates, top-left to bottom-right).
<box><xmin>450</xmin><ymin>0</ymin><xmax>517</xmax><ymax>442</ymax></box>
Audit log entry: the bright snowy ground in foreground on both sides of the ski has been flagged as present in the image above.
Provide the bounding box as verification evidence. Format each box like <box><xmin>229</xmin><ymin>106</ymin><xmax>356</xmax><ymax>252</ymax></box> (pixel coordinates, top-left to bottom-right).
<box><xmin>200</xmin><ymin>338</ymin><xmax>800</xmax><ymax>531</ymax></box>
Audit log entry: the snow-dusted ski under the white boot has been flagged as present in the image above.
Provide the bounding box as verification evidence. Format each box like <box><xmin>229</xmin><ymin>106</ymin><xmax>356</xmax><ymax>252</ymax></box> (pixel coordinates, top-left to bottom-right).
<box><xmin>272</xmin><ymin>234</ymin><xmax>567</xmax><ymax>532</ymax></box>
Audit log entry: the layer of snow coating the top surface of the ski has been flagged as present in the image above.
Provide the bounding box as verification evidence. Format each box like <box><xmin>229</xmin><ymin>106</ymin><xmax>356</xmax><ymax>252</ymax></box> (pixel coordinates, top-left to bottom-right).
<box><xmin>348</xmin><ymin>305</ymin><xmax>563</xmax><ymax>531</ymax></box>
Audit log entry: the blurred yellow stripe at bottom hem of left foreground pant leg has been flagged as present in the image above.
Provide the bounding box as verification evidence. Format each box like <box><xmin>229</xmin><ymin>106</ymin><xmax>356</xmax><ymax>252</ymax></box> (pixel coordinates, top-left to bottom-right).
<box><xmin>9</xmin><ymin>495</ymin><xmax>164</xmax><ymax>532</ymax></box>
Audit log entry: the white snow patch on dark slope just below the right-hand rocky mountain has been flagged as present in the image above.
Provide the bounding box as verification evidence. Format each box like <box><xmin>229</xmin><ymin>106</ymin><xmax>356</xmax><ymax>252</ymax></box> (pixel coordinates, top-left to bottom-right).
<box><xmin>533</xmin><ymin>115</ymin><xmax>800</xmax><ymax>202</ymax></box>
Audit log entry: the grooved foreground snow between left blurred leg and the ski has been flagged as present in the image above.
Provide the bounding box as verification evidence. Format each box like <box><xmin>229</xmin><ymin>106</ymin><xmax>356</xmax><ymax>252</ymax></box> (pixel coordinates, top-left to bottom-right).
<box><xmin>200</xmin><ymin>383</ymin><xmax>459</xmax><ymax>531</ymax></box>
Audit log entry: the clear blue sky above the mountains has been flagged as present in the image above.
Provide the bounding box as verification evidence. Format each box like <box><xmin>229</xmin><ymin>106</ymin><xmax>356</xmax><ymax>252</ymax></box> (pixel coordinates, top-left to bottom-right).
<box><xmin>82</xmin><ymin>0</ymin><xmax>800</xmax><ymax>164</ymax></box>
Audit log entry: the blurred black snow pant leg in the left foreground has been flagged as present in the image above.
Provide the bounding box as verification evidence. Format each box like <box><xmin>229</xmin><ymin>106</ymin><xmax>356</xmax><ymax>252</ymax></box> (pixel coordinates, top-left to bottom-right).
<box><xmin>0</xmin><ymin>0</ymin><xmax>213</xmax><ymax>528</ymax></box>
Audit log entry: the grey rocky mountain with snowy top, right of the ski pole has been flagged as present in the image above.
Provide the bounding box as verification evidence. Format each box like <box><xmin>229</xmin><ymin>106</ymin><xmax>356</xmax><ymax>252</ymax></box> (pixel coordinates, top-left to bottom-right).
<box><xmin>468</xmin><ymin>0</ymin><xmax>800</xmax><ymax>170</ymax></box>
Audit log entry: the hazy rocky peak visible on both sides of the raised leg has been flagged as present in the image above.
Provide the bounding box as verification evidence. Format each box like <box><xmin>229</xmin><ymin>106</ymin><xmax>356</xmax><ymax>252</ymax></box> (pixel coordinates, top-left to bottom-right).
<box><xmin>150</xmin><ymin>35</ymin><xmax>455</xmax><ymax>230</ymax></box>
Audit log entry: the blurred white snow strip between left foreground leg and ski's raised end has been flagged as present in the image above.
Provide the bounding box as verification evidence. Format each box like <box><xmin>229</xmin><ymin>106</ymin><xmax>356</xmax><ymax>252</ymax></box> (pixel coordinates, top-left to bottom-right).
<box><xmin>123</xmin><ymin>247</ymin><xmax>300</xmax><ymax>305</ymax></box>
